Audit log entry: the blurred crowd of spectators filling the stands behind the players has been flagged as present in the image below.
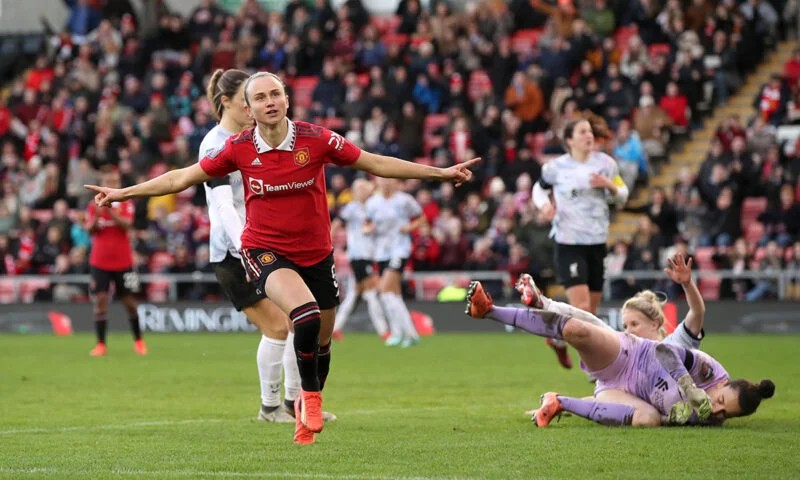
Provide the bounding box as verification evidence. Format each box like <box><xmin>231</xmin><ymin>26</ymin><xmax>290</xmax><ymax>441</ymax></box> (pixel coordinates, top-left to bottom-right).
<box><xmin>0</xmin><ymin>0</ymin><xmax>800</xmax><ymax>298</ymax></box>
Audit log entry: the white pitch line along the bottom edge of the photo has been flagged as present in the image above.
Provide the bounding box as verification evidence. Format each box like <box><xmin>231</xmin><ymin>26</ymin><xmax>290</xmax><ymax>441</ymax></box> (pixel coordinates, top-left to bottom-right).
<box><xmin>0</xmin><ymin>467</ymin><xmax>475</xmax><ymax>480</ymax></box>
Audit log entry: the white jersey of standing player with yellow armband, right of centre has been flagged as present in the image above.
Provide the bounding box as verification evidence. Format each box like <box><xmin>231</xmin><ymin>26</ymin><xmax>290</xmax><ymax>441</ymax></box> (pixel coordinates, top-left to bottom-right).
<box><xmin>539</xmin><ymin>152</ymin><xmax>619</xmax><ymax>245</ymax></box>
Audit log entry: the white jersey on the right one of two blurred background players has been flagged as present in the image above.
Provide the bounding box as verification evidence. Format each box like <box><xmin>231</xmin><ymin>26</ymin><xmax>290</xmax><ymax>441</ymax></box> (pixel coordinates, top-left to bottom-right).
<box><xmin>367</xmin><ymin>192</ymin><xmax>422</xmax><ymax>262</ymax></box>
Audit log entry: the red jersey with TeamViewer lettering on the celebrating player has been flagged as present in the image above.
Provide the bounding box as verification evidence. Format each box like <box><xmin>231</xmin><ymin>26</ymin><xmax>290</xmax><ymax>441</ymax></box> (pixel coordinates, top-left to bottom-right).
<box><xmin>200</xmin><ymin>119</ymin><xmax>361</xmax><ymax>267</ymax></box>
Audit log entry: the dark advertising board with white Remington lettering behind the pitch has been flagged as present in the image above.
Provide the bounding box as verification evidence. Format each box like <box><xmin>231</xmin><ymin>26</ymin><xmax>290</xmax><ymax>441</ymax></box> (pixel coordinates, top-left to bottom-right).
<box><xmin>0</xmin><ymin>302</ymin><xmax>800</xmax><ymax>334</ymax></box>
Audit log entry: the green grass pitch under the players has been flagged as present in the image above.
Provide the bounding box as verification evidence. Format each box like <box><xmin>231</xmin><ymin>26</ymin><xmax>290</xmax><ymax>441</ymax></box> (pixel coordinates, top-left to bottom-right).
<box><xmin>0</xmin><ymin>332</ymin><xmax>800</xmax><ymax>480</ymax></box>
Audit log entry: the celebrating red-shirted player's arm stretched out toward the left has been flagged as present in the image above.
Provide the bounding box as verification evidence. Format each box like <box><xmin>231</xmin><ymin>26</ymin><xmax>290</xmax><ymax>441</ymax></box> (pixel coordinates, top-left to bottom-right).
<box><xmin>84</xmin><ymin>163</ymin><xmax>213</xmax><ymax>207</ymax></box>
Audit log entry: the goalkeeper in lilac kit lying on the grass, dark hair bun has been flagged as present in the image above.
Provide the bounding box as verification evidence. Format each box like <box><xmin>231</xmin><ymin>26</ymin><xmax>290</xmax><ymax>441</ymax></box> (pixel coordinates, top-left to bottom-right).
<box><xmin>466</xmin><ymin>282</ymin><xmax>775</xmax><ymax>427</ymax></box>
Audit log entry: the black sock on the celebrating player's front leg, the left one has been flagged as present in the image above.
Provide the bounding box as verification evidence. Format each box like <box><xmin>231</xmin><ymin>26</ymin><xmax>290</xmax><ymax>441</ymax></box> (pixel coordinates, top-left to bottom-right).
<box><xmin>289</xmin><ymin>302</ymin><xmax>321</xmax><ymax>392</ymax></box>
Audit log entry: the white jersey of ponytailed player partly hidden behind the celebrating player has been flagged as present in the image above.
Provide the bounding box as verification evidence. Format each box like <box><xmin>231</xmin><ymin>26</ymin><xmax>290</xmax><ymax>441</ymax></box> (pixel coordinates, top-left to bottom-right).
<box><xmin>198</xmin><ymin>125</ymin><xmax>245</xmax><ymax>263</ymax></box>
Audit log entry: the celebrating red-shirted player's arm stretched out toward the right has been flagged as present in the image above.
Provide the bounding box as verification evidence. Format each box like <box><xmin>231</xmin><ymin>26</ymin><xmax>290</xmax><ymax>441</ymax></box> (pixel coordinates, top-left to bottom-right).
<box><xmin>352</xmin><ymin>150</ymin><xmax>481</xmax><ymax>186</ymax></box>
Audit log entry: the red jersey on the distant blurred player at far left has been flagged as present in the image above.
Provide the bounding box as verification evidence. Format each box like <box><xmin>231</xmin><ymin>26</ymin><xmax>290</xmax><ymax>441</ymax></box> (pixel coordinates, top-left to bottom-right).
<box><xmin>87</xmin><ymin>202</ymin><xmax>133</xmax><ymax>272</ymax></box>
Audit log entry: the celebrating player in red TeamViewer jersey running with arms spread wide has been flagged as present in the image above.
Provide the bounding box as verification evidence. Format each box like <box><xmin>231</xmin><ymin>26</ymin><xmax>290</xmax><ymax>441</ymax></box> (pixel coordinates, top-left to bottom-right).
<box><xmin>86</xmin><ymin>72</ymin><xmax>480</xmax><ymax>444</ymax></box>
